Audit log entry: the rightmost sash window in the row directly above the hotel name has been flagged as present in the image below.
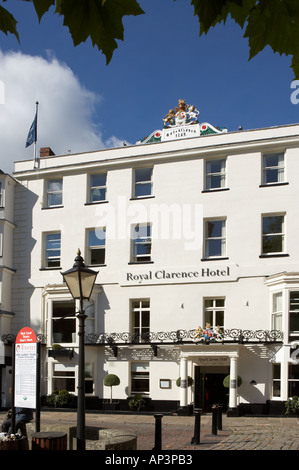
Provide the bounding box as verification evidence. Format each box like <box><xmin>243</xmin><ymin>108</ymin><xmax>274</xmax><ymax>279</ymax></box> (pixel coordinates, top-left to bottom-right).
<box><xmin>262</xmin><ymin>214</ymin><xmax>285</xmax><ymax>255</ymax></box>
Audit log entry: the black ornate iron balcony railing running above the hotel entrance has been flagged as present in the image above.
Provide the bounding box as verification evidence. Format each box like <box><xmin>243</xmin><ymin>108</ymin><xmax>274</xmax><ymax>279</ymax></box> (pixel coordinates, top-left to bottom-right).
<box><xmin>86</xmin><ymin>328</ymin><xmax>283</xmax><ymax>346</ymax></box>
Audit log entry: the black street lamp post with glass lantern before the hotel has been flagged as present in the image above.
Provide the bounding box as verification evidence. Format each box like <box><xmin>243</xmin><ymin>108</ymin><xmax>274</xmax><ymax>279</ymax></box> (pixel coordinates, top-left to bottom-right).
<box><xmin>61</xmin><ymin>250</ymin><xmax>98</xmax><ymax>450</ymax></box>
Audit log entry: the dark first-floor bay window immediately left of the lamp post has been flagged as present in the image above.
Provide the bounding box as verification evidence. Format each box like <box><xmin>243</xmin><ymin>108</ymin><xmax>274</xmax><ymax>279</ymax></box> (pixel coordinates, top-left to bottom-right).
<box><xmin>52</xmin><ymin>300</ymin><xmax>76</xmax><ymax>344</ymax></box>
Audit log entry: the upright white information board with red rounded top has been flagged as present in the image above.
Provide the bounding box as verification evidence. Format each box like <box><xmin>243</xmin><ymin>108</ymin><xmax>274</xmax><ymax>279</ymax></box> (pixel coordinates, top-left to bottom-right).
<box><xmin>14</xmin><ymin>327</ymin><xmax>37</xmax><ymax>408</ymax></box>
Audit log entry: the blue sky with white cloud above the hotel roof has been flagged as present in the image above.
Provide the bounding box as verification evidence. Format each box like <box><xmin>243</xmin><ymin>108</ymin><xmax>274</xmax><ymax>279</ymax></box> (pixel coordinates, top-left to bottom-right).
<box><xmin>0</xmin><ymin>0</ymin><xmax>299</xmax><ymax>174</ymax></box>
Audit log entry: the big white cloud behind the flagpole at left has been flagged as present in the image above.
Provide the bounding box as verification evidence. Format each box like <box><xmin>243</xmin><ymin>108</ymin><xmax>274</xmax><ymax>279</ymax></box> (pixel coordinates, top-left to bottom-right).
<box><xmin>0</xmin><ymin>50</ymin><xmax>117</xmax><ymax>174</ymax></box>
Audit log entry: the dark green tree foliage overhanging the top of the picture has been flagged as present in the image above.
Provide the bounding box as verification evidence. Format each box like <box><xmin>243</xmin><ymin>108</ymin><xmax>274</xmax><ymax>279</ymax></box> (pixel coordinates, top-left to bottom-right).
<box><xmin>0</xmin><ymin>0</ymin><xmax>299</xmax><ymax>78</ymax></box>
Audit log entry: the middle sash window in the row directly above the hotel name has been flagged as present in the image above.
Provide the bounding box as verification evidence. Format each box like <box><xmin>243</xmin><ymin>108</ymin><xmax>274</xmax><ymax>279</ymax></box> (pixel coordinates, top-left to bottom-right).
<box><xmin>132</xmin><ymin>224</ymin><xmax>152</xmax><ymax>263</ymax></box>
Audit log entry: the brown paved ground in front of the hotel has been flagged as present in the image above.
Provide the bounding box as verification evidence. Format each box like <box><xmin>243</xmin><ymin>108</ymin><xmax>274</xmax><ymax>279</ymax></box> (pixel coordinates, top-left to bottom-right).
<box><xmin>0</xmin><ymin>410</ymin><xmax>299</xmax><ymax>452</ymax></box>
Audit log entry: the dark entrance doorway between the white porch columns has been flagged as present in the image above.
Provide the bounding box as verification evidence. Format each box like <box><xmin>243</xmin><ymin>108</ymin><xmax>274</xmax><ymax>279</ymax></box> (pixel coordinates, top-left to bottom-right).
<box><xmin>194</xmin><ymin>366</ymin><xmax>229</xmax><ymax>413</ymax></box>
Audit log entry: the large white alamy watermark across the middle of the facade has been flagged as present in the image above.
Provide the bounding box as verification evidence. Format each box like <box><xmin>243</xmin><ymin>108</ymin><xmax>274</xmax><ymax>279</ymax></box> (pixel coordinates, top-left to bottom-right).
<box><xmin>95</xmin><ymin>196</ymin><xmax>203</xmax><ymax>250</ymax></box>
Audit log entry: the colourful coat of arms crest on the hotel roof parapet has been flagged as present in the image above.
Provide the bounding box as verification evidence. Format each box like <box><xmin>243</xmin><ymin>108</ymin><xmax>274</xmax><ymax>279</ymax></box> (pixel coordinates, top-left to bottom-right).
<box><xmin>137</xmin><ymin>99</ymin><xmax>227</xmax><ymax>144</ymax></box>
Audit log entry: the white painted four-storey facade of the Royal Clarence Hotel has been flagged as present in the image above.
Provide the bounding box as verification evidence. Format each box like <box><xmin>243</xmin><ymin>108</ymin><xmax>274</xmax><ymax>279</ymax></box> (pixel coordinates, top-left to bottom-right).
<box><xmin>5</xmin><ymin>121</ymin><xmax>299</xmax><ymax>410</ymax></box>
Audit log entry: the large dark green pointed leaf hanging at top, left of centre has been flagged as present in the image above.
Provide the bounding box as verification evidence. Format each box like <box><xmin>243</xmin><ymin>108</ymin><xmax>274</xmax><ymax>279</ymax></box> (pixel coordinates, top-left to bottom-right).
<box><xmin>56</xmin><ymin>0</ymin><xmax>144</xmax><ymax>64</ymax></box>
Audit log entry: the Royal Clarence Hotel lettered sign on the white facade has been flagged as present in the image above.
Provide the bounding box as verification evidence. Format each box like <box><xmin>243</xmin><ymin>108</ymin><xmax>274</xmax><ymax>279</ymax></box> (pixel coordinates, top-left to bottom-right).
<box><xmin>121</xmin><ymin>266</ymin><xmax>237</xmax><ymax>286</ymax></box>
